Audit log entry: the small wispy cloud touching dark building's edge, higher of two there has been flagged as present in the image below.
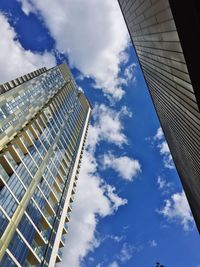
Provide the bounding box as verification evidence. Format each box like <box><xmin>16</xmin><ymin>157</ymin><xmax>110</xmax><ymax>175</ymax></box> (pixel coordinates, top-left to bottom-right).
<box><xmin>154</xmin><ymin>127</ymin><xmax>174</xmax><ymax>169</ymax></box>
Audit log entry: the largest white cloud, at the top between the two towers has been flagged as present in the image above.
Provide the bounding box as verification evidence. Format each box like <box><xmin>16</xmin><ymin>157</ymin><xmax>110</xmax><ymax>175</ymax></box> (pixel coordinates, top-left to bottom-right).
<box><xmin>18</xmin><ymin>0</ymin><xmax>129</xmax><ymax>100</ymax></box>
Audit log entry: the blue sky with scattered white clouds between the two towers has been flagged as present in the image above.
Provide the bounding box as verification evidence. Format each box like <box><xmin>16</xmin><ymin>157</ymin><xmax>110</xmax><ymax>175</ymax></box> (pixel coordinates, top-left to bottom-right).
<box><xmin>0</xmin><ymin>0</ymin><xmax>200</xmax><ymax>267</ymax></box>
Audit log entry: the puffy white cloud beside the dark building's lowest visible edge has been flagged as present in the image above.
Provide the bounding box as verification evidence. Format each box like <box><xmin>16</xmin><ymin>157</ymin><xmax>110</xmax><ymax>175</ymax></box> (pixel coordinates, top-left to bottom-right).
<box><xmin>158</xmin><ymin>191</ymin><xmax>194</xmax><ymax>231</ymax></box>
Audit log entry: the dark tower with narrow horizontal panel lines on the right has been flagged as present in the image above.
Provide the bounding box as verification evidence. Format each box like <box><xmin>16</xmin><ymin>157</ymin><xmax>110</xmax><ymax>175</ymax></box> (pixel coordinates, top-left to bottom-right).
<box><xmin>119</xmin><ymin>0</ymin><xmax>200</xmax><ymax>231</ymax></box>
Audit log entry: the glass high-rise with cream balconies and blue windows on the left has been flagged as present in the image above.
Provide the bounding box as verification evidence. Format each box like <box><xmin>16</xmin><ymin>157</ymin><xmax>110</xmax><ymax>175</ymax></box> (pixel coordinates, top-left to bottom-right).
<box><xmin>0</xmin><ymin>64</ymin><xmax>91</xmax><ymax>267</ymax></box>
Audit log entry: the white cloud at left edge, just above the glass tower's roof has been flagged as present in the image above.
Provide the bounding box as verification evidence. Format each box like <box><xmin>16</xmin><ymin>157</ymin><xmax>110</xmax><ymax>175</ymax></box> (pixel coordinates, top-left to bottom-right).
<box><xmin>0</xmin><ymin>13</ymin><xmax>56</xmax><ymax>83</ymax></box>
